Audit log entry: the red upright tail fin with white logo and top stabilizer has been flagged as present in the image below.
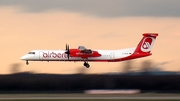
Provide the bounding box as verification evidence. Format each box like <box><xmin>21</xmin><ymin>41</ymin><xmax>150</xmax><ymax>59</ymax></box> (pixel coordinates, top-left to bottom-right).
<box><xmin>134</xmin><ymin>33</ymin><xmax>158</xmax><ymax>55</ymax></box>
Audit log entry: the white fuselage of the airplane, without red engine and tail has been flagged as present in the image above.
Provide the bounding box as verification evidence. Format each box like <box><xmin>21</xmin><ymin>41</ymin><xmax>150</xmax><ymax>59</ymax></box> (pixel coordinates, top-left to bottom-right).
<box><xmin>21</xmin><ymin>48</ymin><xmax>135</xmax><ymax>61</ymax></box>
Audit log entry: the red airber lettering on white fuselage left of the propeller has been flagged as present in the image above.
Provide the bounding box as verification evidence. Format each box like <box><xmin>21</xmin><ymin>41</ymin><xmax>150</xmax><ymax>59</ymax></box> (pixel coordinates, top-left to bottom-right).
<box><xmin>43</xmin><ymin>52</ymin><xmax>67</xmax><ymax>58</ymax></box>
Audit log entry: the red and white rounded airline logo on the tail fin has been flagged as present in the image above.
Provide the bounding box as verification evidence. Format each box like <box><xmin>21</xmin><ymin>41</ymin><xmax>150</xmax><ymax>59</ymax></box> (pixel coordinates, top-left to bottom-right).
<box><xmin>141</xmin><ymin>37</ymin><xmax>155</xmax><ymax>52</ymax></box>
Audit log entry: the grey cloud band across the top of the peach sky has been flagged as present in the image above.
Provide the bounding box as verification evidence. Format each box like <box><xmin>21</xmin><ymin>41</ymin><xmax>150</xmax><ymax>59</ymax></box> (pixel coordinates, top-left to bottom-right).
<box><xmin>0</xmin><ymin>0</ymin><xmax>180</xmax><ymax>17</ymax></box>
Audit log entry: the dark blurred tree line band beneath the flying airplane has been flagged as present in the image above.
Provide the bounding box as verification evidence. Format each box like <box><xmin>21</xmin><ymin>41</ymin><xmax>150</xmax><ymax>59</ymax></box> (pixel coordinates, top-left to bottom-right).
<box><xmin>0</xmin><ymin>73</ymin><xmax>180</xmax><ymax>92</ymax></box>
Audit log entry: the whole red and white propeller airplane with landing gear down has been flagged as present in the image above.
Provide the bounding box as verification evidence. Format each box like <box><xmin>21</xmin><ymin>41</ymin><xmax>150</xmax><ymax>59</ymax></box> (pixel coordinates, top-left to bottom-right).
<box><xmin>20</xmin><ymin>33</ymin><xmax>158</xmax><ymax>68</ymax></box>
